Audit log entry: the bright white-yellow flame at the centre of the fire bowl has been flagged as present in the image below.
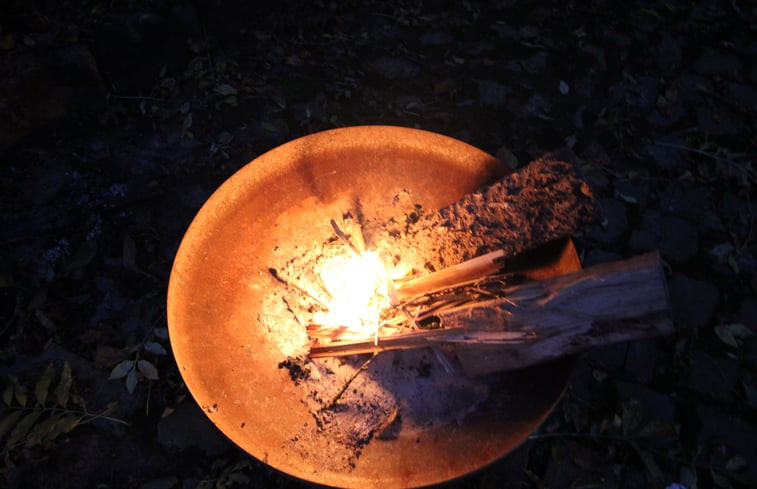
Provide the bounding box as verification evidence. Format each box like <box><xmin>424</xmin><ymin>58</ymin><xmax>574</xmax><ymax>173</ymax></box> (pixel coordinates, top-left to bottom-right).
<box><xmin>313</xmin><ymin>251</ymin><xmax>390</xmax><ymax>342</ymax></box>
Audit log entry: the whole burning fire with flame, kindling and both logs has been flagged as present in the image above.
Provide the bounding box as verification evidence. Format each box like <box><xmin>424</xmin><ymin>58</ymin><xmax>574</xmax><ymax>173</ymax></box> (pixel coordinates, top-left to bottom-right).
<box><xmin>272</xmin><ymin>157</ymin><xmax>673</xmax><ymax>374</ymax></box>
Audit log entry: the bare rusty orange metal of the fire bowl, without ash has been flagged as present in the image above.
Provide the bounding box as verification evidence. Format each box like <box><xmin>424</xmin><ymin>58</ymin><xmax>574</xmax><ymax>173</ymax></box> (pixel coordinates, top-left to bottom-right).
<box><xmin>168</xmin><ymin>126</ymin><xmax>580</xmax><ymax>488</ymax></box>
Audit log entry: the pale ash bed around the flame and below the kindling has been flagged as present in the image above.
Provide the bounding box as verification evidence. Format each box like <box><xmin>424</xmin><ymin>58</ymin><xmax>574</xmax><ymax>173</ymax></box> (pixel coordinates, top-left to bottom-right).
<box><xmin>259</xmin><ymin>190</ymin><xmax>489</xmax><ymax>470</ymax></box>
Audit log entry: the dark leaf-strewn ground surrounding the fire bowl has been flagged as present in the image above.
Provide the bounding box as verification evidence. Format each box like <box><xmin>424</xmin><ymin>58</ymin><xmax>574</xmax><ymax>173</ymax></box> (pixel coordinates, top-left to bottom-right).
<box><xmin>0</xmin><ymin>0</ymin><xmax>757</xmax><ymax>489</ymax></box>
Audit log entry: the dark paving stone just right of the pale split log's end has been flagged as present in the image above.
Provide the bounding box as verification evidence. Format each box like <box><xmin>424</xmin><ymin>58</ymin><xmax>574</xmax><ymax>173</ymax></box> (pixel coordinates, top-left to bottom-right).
<box><xmin>669</xmin><ymin>273</ymin><xmax>720</xmax><ymax>328</ymax></box>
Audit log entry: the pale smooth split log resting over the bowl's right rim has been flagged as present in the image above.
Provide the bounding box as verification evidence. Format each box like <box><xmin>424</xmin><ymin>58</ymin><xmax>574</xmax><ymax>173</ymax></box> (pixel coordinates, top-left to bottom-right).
<box><xmin>447</xmin><ymin>252</ymin><xmax>675</xmax><ymax>375</ymax></box>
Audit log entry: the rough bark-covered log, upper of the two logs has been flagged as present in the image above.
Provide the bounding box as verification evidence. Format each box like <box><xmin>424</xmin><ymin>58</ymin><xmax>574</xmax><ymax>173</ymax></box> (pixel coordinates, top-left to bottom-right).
<box><xmin>403</xmin><ymin>155</ymin><xmax>601</xmax><ymax>270</ymax></box>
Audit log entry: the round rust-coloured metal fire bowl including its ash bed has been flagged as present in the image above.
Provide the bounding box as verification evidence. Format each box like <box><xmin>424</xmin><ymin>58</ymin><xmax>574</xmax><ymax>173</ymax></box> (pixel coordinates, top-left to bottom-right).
<box><xmin>168</xmin><ymin>126</ymin><xmax>580</xmax><ymax>488</ymax></box>
